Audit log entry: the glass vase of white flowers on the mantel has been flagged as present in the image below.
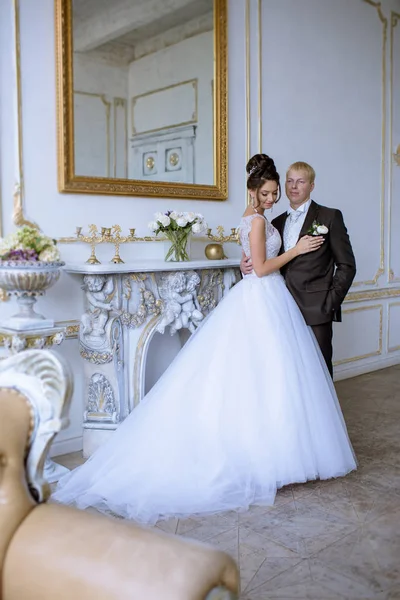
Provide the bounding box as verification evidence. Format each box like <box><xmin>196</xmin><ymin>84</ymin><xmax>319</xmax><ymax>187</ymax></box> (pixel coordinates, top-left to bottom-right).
<box><xmin>149</xmin><ymin>210</ymin><xmax>208</xmax><ymax>262</ymax></box>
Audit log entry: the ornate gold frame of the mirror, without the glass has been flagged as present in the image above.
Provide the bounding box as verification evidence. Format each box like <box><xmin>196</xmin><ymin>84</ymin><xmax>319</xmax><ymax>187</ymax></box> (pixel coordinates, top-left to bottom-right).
<box><xmin>55</xmin><ymin>0</ymin><xmax>228</xmax><ymax>201</ymax></box>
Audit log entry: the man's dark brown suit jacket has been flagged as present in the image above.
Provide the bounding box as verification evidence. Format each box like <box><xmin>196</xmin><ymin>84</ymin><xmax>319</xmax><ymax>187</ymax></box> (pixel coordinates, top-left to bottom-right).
<box><xmin>272</xmin><ymin>201</ymin><xmax>356</xmax><ymax>325</ymax></box>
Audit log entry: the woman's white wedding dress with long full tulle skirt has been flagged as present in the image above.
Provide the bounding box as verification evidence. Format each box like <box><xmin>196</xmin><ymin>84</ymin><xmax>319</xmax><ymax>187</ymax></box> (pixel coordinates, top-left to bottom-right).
<box><xmin>53</xmin><ymin>215</ymin><xmax>356</xmax><ymax>523</ymax></box>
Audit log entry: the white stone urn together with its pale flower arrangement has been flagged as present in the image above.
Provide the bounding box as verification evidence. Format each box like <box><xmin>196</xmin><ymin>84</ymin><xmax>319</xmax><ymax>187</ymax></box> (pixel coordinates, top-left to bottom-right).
<box><xmin>0</xmin><ymin>226</ymin><xmax>64</xmax><ymax>331</ymax></box>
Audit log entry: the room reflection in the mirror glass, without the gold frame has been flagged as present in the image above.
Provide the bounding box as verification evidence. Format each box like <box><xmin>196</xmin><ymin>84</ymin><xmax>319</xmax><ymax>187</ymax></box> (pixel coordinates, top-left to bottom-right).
<box><xmin>72</xmin><ymin>0</ymin><xmax>215</xmax><ymax>185</ymax></box>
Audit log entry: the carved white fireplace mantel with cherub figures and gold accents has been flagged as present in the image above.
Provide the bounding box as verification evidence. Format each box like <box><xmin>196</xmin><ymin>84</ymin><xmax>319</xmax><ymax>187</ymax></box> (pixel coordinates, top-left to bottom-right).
<box><xmin>65</xmin><ymin>259</ymin><xmax>240</xmax><ymax>457</ymax></box>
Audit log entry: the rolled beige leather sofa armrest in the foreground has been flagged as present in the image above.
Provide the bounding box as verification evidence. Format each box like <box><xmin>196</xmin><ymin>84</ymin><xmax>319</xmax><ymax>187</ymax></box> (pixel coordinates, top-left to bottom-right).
<box><xmin>3</xmin><ymin>503</ymin><xmax>239</xmax><ymax>600</ymax></box>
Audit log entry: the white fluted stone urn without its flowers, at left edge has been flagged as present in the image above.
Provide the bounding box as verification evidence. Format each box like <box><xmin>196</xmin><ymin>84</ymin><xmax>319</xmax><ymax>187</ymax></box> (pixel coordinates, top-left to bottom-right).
<box><xmin>0</xmin><ymin>260</ymin><xmax>65</xmax><ymax>331</ymax></box>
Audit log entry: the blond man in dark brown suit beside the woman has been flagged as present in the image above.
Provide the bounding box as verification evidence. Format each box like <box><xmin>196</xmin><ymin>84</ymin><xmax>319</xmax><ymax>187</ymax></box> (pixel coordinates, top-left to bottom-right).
<box><xmin>240</xmin><ymin>162</ymin><xmax>356</xmax><ymax>375</ymax></box>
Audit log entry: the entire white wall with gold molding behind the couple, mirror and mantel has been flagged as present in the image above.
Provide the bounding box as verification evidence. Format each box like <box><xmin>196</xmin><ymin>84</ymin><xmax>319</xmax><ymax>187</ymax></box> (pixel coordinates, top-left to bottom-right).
<box><xmin>0</xmin><ymin>0</ymin><xmax>400</xmax><ymax>450</ymax></box>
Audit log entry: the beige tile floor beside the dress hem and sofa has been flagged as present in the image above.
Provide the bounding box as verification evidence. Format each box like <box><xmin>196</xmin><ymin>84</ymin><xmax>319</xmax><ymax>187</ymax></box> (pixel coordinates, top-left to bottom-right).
<box><xmin>58</xmin><ymin>366</ymin><xmax>400</xmax><ymax>600</ymax></box>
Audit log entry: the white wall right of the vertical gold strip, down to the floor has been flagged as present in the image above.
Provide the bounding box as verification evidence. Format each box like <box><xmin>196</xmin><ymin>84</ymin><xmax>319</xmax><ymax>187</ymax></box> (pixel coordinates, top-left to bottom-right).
<box><xmin>249</xmin><ymin>0</ymin><xmax>400</xmax><ymax>378</ymax></box>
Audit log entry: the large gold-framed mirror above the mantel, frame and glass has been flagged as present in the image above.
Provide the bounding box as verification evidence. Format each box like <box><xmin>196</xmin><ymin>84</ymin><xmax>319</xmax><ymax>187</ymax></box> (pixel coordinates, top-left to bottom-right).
<box><xmin>55</xmin><ymin>0</ymin><xmax>228</xmax><ymax>200</ymax></box>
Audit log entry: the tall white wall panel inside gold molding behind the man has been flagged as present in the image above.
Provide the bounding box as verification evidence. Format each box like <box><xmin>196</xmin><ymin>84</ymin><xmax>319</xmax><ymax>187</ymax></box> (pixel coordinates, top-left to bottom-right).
<box><xmin>262</xmin><ymin>0</ymin><xmax>384</xmax><ymax>282</ymax></box>
